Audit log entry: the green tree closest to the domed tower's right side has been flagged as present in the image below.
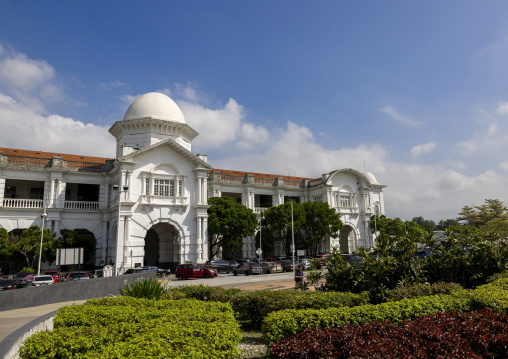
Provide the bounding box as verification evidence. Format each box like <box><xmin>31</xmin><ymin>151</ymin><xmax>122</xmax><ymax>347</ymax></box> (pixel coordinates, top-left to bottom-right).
<box><xmin>208</xmin><ymin>196</ymin><xmax>258</xmax><ymax>258</ymax></box>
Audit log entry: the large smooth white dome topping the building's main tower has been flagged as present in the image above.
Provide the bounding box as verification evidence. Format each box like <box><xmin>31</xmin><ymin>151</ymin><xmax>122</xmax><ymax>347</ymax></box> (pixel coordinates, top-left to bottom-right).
<box><xmin>123</xmin><ymin>92</ymin><xmax>185</xmax><ymax>123</ymax></box>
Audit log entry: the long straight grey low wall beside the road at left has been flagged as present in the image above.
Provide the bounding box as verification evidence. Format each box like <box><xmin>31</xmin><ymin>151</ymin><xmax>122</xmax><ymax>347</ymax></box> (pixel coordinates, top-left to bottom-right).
<box><xmin>0</xmin><ymin>272</ymin><xmax>156</xmax><ymax>311</ymax></box>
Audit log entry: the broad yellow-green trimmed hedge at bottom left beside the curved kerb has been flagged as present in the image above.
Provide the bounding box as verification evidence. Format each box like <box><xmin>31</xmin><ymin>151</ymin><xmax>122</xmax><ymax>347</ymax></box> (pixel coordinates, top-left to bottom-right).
<box><xmin>20</xmin><ymin>297</ymin><xmax>242</xmax><ymax>359</ymax></box>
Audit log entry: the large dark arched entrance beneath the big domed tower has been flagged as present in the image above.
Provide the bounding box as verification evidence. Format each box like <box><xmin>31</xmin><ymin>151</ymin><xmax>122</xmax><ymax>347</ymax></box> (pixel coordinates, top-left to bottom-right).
<box><xmin>143</xmin><ymin>223</ymin><xmax>179</xmax><ymax>270</ymax></box>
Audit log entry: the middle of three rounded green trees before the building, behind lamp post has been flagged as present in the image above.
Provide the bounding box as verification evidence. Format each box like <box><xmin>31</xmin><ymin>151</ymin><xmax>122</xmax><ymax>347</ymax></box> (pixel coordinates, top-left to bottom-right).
<box><xmin>263</xmin><ymin>202</ymin><xmax>305</xmax><ymax>253</ymax></box>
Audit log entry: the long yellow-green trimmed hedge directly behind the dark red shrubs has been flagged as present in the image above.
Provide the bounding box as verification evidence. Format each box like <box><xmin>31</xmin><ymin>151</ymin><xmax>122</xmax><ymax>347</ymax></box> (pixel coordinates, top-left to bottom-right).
<box><xmin>261</xmin><ymin>289</ymin><xmax>470</xmax><ymax>343</ymax></box>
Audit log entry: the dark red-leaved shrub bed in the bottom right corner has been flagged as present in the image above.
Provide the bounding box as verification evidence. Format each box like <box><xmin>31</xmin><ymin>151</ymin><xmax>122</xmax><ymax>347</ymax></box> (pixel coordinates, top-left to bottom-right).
<box><xmin>271</xmin><ymin>309</ymin><xmax>508</xmax><ymax>359</ymax></box>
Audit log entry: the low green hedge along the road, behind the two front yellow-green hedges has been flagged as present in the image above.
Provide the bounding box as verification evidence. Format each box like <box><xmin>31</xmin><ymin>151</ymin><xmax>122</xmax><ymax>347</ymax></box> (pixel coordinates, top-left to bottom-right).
<box><xmin>168</xmin><ymin>285</ymin><xmax>369</xmax><ymax>328</ymax></box>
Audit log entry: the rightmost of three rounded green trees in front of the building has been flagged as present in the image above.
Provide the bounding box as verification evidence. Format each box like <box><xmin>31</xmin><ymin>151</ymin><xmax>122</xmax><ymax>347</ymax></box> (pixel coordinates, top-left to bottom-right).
<box><xmin>302</xmin><ymin>202</ymin><xmax>344</xmax><ymax>255</ymax></box>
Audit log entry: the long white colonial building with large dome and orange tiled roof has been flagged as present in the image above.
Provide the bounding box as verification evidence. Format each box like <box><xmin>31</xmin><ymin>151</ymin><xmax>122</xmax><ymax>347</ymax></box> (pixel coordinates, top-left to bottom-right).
<box><xmin>0</xmin><ymin>93</ymin><xmax>385</xmax><ymax>273</ymax></box>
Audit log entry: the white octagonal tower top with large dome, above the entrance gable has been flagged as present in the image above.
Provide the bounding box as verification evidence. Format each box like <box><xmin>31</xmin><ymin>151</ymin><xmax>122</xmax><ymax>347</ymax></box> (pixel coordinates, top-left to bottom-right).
<box><xmin>109</xmin><ymin>92</ymin><xmax>198</xmax><ymax>158</ymax></box>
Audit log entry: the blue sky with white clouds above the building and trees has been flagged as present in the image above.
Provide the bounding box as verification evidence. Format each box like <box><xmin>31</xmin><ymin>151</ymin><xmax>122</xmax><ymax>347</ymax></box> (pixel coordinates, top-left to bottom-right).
<box><xmin>0</xmin><ymin>0</ymin><xmax>508</xmax><ymax>221</ymax></box>
